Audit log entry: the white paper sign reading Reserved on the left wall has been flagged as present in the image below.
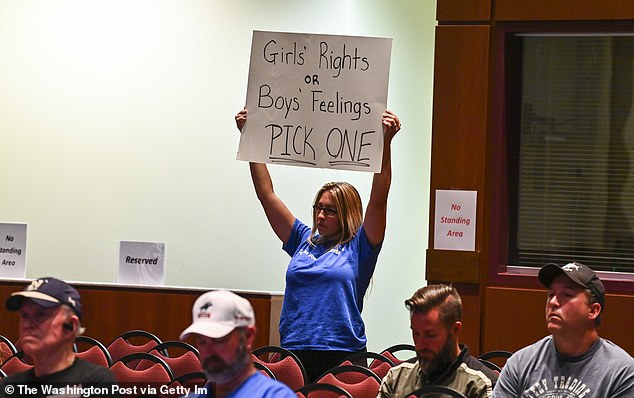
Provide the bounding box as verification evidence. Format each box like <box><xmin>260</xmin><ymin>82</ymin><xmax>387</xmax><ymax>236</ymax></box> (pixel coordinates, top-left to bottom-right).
<box><xmin>117</xmin><ymin>241</ymin><xmax>165</xmax><ymax>285</ymax></box>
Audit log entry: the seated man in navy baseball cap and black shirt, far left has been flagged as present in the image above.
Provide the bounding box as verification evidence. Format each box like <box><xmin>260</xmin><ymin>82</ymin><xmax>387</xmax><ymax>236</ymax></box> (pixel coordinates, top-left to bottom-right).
<box><xmin>0</xmin><ymin>277</ymin><xmax>116</xmax><ymax>397</ymax></box>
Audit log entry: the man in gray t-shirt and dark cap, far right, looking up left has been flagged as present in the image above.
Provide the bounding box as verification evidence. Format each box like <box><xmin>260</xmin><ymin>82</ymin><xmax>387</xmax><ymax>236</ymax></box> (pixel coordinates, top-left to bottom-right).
<box><xmin>493</xmin><ymin>263</ymin><xmax>634</xmax><ymax>398</ymax></box>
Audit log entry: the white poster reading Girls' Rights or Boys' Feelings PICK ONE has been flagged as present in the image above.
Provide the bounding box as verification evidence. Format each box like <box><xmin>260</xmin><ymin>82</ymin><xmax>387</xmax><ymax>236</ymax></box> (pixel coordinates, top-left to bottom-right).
<box><xmin>238</xmin><ymin>31</ymin><xmax>392</xmax><ymax>172</ymax></box>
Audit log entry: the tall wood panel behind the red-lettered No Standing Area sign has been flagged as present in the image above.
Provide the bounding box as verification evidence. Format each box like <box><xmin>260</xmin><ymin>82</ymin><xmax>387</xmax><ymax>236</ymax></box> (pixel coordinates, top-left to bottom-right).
<box><xmin>427</xmin><ymin>26</ymin><xmax>489</xmax><ymax>283</ymax></box>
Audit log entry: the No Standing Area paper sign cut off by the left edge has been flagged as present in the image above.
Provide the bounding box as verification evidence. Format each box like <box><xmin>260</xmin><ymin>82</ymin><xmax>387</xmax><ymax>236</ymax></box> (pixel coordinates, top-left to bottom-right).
<box><xmin>0</xmin><ymin>223</ymin><xmax>26</xmax><ymax>278</ymax></box>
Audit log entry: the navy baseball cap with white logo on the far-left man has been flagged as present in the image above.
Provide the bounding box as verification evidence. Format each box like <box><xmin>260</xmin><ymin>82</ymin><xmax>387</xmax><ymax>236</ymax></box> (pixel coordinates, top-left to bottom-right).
<box><xmin>5</xmin><ymin>277</ymin><xmax>81</xmax><ymax>319</ymax></box>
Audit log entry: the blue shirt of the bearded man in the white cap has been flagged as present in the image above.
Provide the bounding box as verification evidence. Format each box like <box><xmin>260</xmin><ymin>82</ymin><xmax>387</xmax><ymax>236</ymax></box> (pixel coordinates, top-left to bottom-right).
<box><xmin>186</xmin><ymin>372</ymin><xmax>297</xmax><ymax>398</ymax></box>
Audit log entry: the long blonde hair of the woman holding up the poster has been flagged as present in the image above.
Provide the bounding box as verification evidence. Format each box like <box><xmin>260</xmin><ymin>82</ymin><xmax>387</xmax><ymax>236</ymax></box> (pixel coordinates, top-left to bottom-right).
<box><xmin>308</xmin><ymin>182</ymin><xmax>363</xmax><ymax>246</ymax></box>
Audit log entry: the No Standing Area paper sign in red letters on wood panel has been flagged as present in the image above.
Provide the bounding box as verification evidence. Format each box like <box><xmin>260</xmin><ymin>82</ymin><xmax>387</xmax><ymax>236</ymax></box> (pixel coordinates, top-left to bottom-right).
<box><xmin>434</xmin><ymin>190</ymin><xmax>478</xmax><ymax>251</ymax></box>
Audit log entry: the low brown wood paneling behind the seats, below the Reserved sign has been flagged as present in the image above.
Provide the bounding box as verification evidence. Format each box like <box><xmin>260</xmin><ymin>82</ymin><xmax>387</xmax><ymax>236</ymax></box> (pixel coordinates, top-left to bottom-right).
<box><xmin>0</xmin><ymin>281</ymin><xmax>281</xmax><ymax>347</ymax></box>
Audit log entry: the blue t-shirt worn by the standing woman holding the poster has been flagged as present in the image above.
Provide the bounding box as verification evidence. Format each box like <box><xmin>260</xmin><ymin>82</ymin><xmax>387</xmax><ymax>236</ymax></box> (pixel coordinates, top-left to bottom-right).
<box><xmin>280</xmin><ymin>219</ymin><xmax>381</xmax><ymax>351</ymax></box>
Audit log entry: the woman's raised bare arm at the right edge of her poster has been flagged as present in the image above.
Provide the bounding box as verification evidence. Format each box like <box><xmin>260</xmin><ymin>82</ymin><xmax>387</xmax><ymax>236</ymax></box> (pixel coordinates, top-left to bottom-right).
<box><xmin>363</xmin><ymin>110</ymin><xmax>401</xmax><ymax>246</ymax></box>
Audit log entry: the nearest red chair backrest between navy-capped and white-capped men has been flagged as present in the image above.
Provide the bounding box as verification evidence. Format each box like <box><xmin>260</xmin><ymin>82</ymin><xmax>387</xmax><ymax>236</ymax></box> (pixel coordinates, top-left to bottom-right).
<box><xmin>110</xmin><ymin>352</ymin><xmax>174</xmax><ymax>386</ymax></box>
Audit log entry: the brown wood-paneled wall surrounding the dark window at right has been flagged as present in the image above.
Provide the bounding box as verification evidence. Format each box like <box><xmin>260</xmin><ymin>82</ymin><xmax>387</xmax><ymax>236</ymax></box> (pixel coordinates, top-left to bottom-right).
<box><xmin>426</xmin><ymin>0</ymin><xmax>634</xmax><ymax>354</ymax></box>
